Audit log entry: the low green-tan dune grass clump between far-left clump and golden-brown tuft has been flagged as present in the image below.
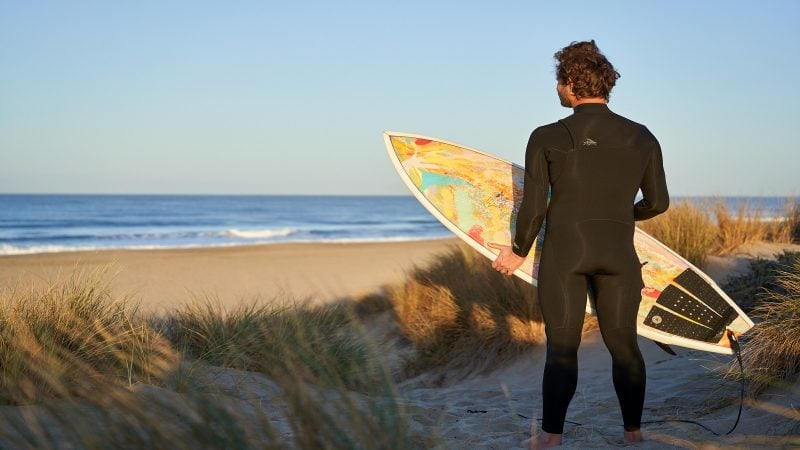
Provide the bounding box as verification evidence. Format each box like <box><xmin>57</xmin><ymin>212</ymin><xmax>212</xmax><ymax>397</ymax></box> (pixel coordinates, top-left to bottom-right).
<box><xmin>163</xmin><ymin>298</ymin><xmax>378</xmax><ymax>389</ymax></box>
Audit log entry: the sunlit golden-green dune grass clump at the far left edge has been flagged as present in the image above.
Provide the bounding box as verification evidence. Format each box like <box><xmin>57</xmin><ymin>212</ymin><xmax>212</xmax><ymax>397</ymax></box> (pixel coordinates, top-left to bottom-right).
<box><xmin>0</xmin><ymin>272</ymin><xmax>177</xmax><ymax>404</ymax></box>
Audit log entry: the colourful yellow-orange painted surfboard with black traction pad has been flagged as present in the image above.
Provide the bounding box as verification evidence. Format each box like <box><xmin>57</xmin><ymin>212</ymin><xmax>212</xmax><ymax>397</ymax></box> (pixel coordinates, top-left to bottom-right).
<box><xmin>384</xmin><ymin>131</ymin><xmax>753</xmax><ymax>354</ymax></box>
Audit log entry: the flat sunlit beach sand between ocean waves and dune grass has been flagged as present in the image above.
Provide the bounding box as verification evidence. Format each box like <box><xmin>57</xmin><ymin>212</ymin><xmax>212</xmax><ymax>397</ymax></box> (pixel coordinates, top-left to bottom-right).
<box><xmin>0</xmin><ymin>237</ymin><xmax>458</xmax><ymax>313</ymax></box>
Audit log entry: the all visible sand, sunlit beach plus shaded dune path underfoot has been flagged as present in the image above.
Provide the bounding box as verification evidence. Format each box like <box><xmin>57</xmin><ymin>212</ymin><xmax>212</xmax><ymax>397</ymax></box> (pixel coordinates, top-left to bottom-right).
<box><xmin>0</xmin><ymin>240</ymin><xmax>800</xmax><ymax>449</ymax></box>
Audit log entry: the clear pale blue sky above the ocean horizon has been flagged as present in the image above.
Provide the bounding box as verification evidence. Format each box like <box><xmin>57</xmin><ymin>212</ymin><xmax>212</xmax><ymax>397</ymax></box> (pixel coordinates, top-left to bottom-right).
<box><xmin>0</xmin><ymin>0</ymin><xmax>800</xmax><ymax>195</ymax></box>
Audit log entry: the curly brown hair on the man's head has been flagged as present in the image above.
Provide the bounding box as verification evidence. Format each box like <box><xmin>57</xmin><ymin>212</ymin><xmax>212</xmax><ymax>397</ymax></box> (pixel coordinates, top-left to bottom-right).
<box><xmin>553</xmin><ymin>39</ymin><xmax>620</xmax><ymax>100</ymax></box>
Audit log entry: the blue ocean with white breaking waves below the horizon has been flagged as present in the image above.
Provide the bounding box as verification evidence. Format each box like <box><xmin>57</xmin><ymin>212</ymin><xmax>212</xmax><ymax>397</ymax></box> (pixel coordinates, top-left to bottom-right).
<box><xmin>0</xmin><ymin>195</ymin><xmax>789</xmax><ymax>255</ymax></box>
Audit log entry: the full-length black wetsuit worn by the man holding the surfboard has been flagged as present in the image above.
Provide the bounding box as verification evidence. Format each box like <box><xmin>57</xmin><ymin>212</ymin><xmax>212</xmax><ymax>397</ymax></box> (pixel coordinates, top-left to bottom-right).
<box><xmin>513</xmin><ymin>104</ymin><xmax>669</xmax><ymax>434</ymax></box>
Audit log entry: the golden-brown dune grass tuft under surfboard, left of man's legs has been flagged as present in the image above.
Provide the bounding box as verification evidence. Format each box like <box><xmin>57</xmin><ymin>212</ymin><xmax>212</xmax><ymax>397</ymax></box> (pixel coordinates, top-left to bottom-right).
<box><xmin>372</xmin><ymin>244</ymin><xmax>597</xmax><ymax>376</ymax></box>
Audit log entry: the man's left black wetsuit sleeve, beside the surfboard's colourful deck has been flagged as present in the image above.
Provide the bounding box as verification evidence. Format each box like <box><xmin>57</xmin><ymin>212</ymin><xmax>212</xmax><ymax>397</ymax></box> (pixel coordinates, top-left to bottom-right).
<box><xmin>512</xmin><ymin>130</ymin><xmax>550</xmax><ymax>256</ymax></box>
